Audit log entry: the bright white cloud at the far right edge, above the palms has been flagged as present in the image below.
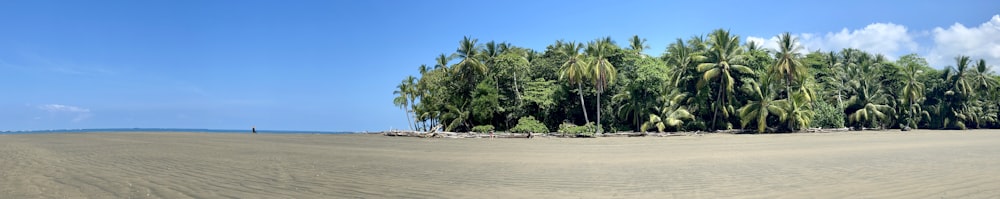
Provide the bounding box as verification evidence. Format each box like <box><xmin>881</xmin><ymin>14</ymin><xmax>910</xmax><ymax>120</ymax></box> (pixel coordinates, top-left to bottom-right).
<box><xmin>926</xmin><ymin>15</ymin><xmax>1000</xmax><ymax>70</ymax></box>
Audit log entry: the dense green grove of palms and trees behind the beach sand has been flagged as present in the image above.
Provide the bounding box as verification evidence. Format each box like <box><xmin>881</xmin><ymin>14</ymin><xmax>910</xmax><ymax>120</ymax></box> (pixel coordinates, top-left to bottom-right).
<box><xmin>393</xmin><ymin>29</ymin><xmax>1000</xmax><ymax>133</ymax></box>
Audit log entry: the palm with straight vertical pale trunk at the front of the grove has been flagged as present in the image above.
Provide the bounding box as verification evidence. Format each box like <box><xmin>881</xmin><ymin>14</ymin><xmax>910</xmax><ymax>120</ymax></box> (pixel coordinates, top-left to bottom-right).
<box><xmin>586</xmin><ymin>37</ymin><xmax>618</xmax><ymax>134</ymax></box>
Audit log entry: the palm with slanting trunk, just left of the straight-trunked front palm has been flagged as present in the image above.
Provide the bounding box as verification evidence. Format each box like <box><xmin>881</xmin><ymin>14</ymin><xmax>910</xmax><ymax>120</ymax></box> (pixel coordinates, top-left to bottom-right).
<box><xmin>557</xmin><ymin>41</ymin><xmax>590</xmax><ymax>124</ymax></box>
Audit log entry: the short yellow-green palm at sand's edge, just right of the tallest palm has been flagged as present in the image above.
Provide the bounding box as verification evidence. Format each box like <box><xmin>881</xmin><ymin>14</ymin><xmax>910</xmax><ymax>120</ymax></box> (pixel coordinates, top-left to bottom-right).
<box><xmin>737</xmin><ymin>73</ymin><xmax>785</xmax><ymax>133</ymax></box>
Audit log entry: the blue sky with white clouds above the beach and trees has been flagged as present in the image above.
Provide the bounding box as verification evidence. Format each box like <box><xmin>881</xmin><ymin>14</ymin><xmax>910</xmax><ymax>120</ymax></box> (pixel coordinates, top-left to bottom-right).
<box><xmin>0</xmin><ymin>0</ymin><xmax>1000</xmax><ymax>131</ymax></box>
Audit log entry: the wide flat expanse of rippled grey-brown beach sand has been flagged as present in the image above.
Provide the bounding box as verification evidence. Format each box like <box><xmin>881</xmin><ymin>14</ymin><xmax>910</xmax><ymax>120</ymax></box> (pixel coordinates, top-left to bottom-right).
<box><xmin>0</xmin><ymin>130</ymin><xmax>1000</xmax><ymax>198</ymax></box>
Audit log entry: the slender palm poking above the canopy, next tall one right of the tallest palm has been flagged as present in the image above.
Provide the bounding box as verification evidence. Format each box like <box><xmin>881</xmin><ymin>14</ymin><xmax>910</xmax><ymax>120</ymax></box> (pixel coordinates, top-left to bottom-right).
<box><xmin>769</xmin><ymin>32</ymin><xmax>808</xmax><ymax>96</ymax></box>
